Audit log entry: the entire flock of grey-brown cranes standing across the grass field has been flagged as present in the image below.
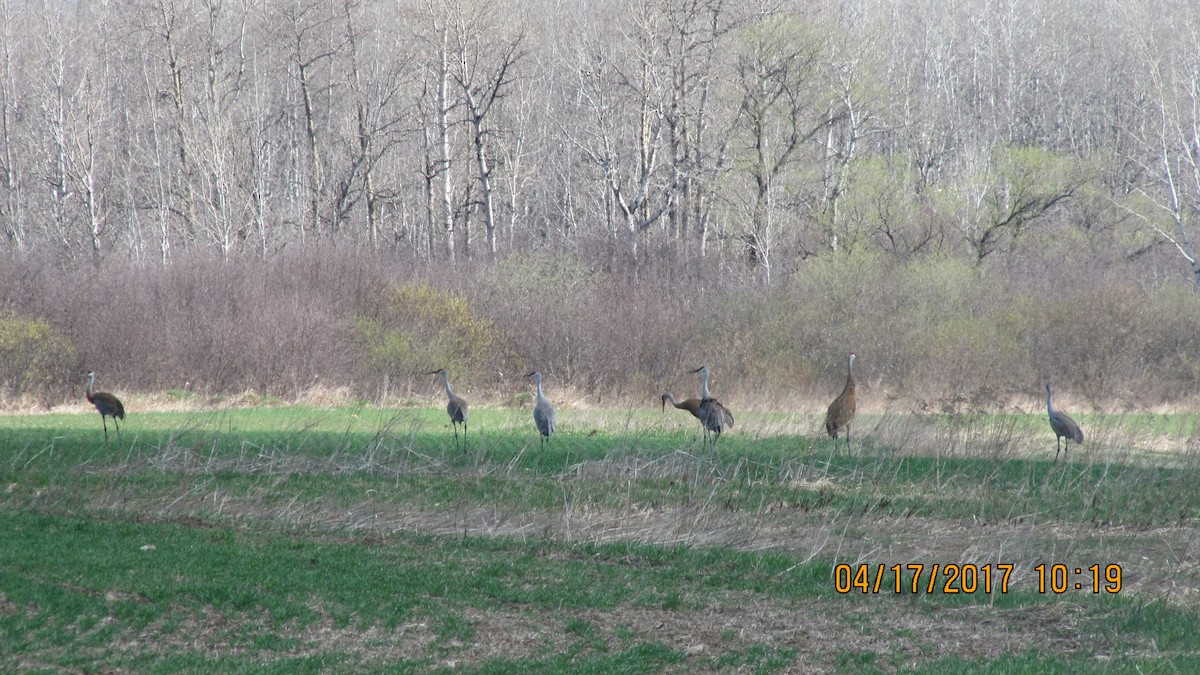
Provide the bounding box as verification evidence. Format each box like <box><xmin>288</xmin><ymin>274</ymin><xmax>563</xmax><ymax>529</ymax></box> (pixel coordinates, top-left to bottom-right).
<box><xmin>79</xmin><ymin>352</ymin><xmax>1084</xmax><ymax>462</ymax></box>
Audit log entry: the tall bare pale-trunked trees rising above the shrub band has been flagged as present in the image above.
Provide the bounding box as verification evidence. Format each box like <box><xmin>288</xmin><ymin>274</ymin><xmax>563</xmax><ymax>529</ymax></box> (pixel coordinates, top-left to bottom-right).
<box><xmin>0</xmin><ymin>0</ymin><xmax>1200</xmax><ymax>283</ymax></box>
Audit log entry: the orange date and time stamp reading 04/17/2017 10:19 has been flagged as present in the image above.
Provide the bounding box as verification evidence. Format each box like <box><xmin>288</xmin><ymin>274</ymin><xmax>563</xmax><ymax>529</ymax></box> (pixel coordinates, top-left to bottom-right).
<box><xmin>833</xmin><ymin>562</ymin><xmax>1121</xmax><ymax>595</ymax></box>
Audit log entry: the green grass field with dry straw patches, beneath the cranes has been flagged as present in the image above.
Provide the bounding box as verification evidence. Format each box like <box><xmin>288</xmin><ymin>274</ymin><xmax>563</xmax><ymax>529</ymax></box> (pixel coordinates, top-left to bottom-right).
<box><xmin>0</xmin><ymin>406</ymin><xmax>1200</xmax><ymax>673</ymax></box>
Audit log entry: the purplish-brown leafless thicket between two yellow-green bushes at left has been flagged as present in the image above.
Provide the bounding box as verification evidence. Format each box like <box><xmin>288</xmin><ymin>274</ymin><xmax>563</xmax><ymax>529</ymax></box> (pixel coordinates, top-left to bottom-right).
<box><xmin>0</xmin><ymin>249</ymin><xmax>386</xmax><ymax>396</ymax></box>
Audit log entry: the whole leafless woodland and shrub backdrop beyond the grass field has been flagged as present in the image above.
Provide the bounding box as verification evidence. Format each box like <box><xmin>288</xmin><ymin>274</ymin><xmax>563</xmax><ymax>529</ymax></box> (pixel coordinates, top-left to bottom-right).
<box><xmin>0</xmin><ymin>0</ymin><xmax>1200</xmax><ymax>411</ymax></box>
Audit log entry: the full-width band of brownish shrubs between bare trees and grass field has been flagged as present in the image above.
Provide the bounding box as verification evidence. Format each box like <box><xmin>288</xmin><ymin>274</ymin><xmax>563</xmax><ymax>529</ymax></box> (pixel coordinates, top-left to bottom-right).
<box><xmin>0</xmin><ymin>246</ymin><xmax>1200</xmax><ymax>410</ymax></box>
